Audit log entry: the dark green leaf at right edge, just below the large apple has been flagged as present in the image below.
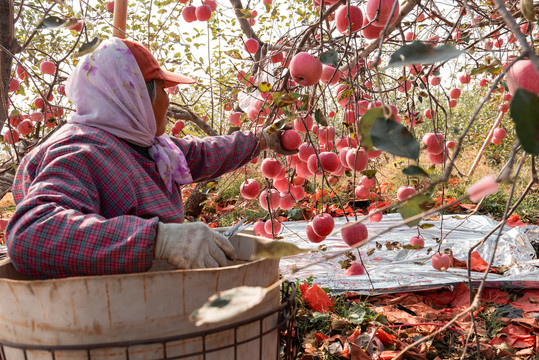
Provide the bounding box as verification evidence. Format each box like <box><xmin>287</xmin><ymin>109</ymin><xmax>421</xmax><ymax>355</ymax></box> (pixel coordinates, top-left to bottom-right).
<box><xmin>509</xmin><ymin>88</ymin><xmax>539</xmax><ymax>155</ymax></box>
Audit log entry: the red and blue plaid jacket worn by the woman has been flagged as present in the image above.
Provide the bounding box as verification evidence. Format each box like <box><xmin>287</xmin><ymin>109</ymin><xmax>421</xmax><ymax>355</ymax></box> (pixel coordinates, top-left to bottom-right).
<box><xmin>5</xmin><ymin>124</ymin><xmax>260</xmax><ymax>278</ymax></box>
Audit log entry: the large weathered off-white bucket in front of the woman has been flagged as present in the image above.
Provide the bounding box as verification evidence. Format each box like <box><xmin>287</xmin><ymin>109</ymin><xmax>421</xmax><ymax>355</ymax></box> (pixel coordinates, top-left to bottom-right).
<box><xmin>0</xmin><ymin>234</ymin><xmax>286</xmax><ymax>360</ymax></box>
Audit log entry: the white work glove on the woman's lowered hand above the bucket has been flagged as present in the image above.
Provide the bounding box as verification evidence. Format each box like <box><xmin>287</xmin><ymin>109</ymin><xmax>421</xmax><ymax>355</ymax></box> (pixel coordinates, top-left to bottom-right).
<box><xmin>154</xmin><ymin>222</ymin><xmax>236</xmax><ymax>269</ymax></box>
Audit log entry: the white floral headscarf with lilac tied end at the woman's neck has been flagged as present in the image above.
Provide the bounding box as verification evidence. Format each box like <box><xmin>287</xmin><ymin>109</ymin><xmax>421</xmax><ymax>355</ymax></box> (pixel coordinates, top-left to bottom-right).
<box><xmin>66</xmin><ymin>38</ymin><xmax>193</xmax><ymax>191</ymax></box>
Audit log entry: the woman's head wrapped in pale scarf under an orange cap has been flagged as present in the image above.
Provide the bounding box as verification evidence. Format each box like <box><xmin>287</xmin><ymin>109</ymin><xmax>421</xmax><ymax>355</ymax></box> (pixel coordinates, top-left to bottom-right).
<box><xmin>66</xmin><ymin>38</ymin><xmax>195</xmax><ymax>146</ymax></box>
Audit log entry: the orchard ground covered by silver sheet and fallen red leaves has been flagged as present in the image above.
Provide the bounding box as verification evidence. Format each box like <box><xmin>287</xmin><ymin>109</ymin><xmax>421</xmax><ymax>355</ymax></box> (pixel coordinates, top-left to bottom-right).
<box><xmin>281</xmin><ymin>214</ymin><xmax>539</xmax><ymax>360</ymax></box>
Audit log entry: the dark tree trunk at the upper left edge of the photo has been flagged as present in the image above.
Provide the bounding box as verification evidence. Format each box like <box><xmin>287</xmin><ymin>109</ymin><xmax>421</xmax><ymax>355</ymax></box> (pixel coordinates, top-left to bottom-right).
<box><xmin>0</xmin><ymin>0</ymin><xmax>15</xmax><ymax>129</ymax></box>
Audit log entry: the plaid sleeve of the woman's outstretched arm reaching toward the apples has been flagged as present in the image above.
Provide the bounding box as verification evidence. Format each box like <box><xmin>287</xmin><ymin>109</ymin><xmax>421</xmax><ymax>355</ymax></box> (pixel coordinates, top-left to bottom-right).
<box><xmin>174</xmin><ymin>131</ymin><xmax>260</xmax><ymax>182</ymax></box>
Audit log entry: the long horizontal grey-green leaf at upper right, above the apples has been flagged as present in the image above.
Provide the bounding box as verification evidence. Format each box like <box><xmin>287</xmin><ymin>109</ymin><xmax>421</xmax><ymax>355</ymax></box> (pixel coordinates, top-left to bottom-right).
<box><xmin>387</xmin><ymin>41</ymin><xmax>465</xmax><ymax>68</ymax></box>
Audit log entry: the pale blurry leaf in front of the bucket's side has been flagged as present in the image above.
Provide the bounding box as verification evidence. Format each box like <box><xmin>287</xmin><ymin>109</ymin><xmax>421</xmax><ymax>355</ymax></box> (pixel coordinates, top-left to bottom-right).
<box><xmin>189</xmin><ymin>286</ymin><xmax>266</xmax><ymax>326</ymax></box>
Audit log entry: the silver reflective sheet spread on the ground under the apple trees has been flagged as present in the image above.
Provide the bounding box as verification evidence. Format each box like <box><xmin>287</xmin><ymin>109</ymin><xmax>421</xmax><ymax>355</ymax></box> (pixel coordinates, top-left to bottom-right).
<box><xmin>280</xmin><ymin>214</ymin><xmax>539</xmax><ymax>294</ymax></box>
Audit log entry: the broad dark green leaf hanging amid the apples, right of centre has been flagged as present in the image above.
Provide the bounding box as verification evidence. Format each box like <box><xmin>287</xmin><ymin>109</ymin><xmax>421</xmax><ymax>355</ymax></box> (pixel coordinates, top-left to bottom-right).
<box><xmin>369</xmin><ymin>117</ymin><xmax>420</xmax><ymax>160</ymax></box>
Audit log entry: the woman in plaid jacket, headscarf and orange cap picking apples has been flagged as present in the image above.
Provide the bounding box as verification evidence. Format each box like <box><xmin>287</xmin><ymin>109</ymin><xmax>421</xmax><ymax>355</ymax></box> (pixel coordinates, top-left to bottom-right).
<box><xmin>6</xmin><ymin>38</ymin><xmax>292</xmax><ymax>278</ymax></box>
